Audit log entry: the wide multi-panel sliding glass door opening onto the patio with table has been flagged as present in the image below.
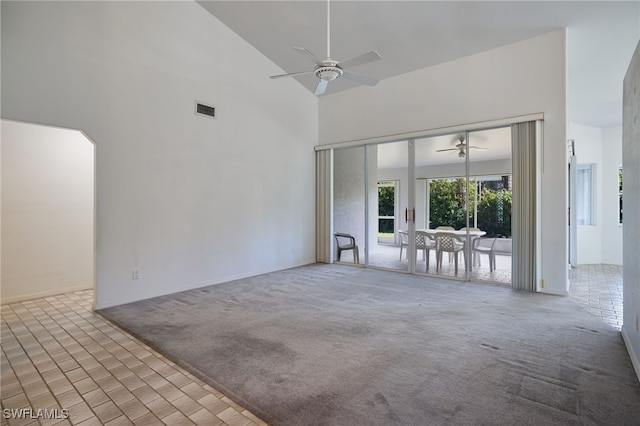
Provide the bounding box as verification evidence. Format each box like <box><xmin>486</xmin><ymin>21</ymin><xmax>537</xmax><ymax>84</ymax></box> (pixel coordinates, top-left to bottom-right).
<box><xmin>333</xmin><ymin>127</ymin><xmax>511</xmax><ymax>284</ymax></box>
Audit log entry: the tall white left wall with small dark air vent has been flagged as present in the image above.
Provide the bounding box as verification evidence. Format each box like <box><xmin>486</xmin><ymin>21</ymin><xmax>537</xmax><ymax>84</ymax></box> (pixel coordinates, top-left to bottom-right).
<box><xmin>1</xmin><ymin>2</ymin><xmax>318</xmax><ymax>308</ymax></box>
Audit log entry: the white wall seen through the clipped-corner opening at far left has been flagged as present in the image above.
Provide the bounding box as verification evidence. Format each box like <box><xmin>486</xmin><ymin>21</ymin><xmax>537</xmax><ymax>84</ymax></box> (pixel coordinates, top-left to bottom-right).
<box><xmin>0</xmin><ymin>120</ymin><xmax>95</xmax><ymax>303</ymax></box>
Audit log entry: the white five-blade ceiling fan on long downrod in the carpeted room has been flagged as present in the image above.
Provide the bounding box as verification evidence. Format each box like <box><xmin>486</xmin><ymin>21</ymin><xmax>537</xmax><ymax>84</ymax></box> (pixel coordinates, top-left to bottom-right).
<box><xmin>271</xmin><ymin>0</ymin><xmax>382</xmax><ymax>96</ymax></box>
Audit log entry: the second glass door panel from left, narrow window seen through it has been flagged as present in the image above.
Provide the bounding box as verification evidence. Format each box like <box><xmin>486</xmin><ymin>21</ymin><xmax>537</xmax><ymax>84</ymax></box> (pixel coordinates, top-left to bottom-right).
<box><xmin>367</xmin><ymin>141</ymin><xmax>410</xmax><ymax>271</ymax></box>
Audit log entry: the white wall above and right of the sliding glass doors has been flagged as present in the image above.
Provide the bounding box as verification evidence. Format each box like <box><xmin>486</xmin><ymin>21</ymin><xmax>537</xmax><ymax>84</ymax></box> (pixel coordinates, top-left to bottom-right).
<box><xmin>319</xmin><ymin>31</ymin><xmax>568</xmax><ymax>294</ymax></box>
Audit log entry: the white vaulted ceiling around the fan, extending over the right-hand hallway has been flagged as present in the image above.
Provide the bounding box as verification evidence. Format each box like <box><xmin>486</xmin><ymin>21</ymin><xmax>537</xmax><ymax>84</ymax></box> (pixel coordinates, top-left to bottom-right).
<box><xmin>198</xmin><ymin>0</ymin><xmax>640</xmax><ymax>127</ymax></box>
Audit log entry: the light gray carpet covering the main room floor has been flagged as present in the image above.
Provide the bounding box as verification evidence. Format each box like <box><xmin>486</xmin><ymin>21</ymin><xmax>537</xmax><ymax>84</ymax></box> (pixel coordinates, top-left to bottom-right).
<box><xmin>101</xmin><ymin>265</ymin><xmax>640</xmax><ymax>425</ymax></box>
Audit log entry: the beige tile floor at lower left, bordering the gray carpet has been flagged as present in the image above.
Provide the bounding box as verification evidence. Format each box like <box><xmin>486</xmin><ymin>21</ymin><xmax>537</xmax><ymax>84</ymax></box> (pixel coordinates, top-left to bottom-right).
<box><xmin>0</xmin><ymin>291</ymin><xmax>266</xmax><ymax>426</ymax></box>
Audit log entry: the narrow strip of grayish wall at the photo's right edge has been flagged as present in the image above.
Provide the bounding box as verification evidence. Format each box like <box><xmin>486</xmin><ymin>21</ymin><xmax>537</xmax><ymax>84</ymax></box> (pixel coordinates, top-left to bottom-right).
<box><xmin>622</xmin><ymin>43</ymin><xmax>640</xmax><ymax>379</ymax></box>
